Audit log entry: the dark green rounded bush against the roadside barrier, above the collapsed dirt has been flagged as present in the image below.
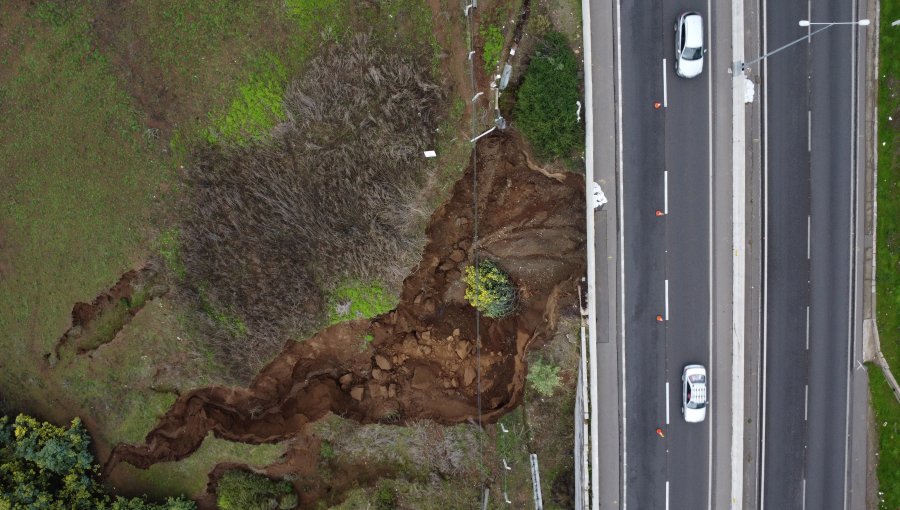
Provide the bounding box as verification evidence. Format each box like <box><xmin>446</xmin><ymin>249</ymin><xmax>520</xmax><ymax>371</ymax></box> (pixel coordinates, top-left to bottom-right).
<box><xmin>515</xmin><ymin>32</ymin><xmax>584</xmax><ymax>159</ymax></box>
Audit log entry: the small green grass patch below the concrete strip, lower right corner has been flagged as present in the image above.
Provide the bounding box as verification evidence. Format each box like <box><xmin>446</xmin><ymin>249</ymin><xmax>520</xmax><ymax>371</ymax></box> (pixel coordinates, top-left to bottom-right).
<box><xmin>868</xmin><ymin>364</ymin><xmax>900</xmax><ymax>510</ymax></box>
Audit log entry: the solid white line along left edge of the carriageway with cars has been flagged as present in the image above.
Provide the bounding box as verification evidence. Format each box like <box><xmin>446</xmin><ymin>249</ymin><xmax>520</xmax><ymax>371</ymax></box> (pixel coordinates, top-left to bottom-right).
<box><xmin>612</xmin><ymin>0</ymin><xmax>628</xmax><ymax>510</ymax></box>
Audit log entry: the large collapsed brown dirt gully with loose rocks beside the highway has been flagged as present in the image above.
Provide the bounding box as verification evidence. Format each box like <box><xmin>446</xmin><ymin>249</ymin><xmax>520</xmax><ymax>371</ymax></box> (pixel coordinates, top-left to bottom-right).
<box><xmin>104</xmin><ymin>135</ymin><xmax>584</xmax><ymax>502</ymax></box>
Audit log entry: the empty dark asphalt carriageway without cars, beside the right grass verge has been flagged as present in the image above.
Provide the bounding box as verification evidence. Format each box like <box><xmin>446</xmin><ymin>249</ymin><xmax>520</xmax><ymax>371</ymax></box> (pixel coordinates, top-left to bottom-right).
<box><xmin>760</xmin><ymin>0</ymin><xmax>858</xmax><ymax>509</ymax></box>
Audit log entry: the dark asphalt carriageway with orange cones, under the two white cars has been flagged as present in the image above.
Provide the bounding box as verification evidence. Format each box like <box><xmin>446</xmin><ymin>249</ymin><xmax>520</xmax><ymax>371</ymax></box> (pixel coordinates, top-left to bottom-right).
<box><xmin>620</xmin><ymin>0</ymin><xmax>716</xmax><ymax>509</ymax></box>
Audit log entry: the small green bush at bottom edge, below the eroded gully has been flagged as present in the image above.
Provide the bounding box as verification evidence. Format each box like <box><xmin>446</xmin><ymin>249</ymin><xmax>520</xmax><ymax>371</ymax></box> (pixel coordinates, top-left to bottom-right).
<box><xmin>216</xmin><ymin>469</ymin><xmax>297</xmax><ymax>510</ymax></box>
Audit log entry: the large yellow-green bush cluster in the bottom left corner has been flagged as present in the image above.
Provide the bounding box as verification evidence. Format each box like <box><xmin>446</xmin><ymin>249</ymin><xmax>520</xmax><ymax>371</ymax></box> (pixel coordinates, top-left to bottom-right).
<box><xmin>0</xmin><ymin>414</ymin><xmax>196</xmax><ymax>510</ymax></box>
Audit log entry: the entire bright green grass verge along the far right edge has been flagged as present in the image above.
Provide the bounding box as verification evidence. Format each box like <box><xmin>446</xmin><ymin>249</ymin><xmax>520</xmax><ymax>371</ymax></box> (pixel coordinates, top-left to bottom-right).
<box><xmin>869</xmin><ymin>2</ymin><xmax>900</xmax><ymax>510</ymax></box>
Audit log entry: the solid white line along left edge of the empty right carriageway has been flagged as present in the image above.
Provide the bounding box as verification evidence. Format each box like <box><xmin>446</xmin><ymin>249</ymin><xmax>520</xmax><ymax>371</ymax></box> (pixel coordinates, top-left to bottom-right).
<box><xmin>759</xmin><ymin>0</ymin><xmax>769</xmax><ymax>504</ymax></box>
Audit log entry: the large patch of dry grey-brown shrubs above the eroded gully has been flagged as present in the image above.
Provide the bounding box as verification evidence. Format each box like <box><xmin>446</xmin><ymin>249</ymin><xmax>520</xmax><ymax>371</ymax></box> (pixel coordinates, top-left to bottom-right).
<box><xmin>182</xmin><ymin>36</ymin><xmax>442</xmax><ymax>374</ymax></box>
